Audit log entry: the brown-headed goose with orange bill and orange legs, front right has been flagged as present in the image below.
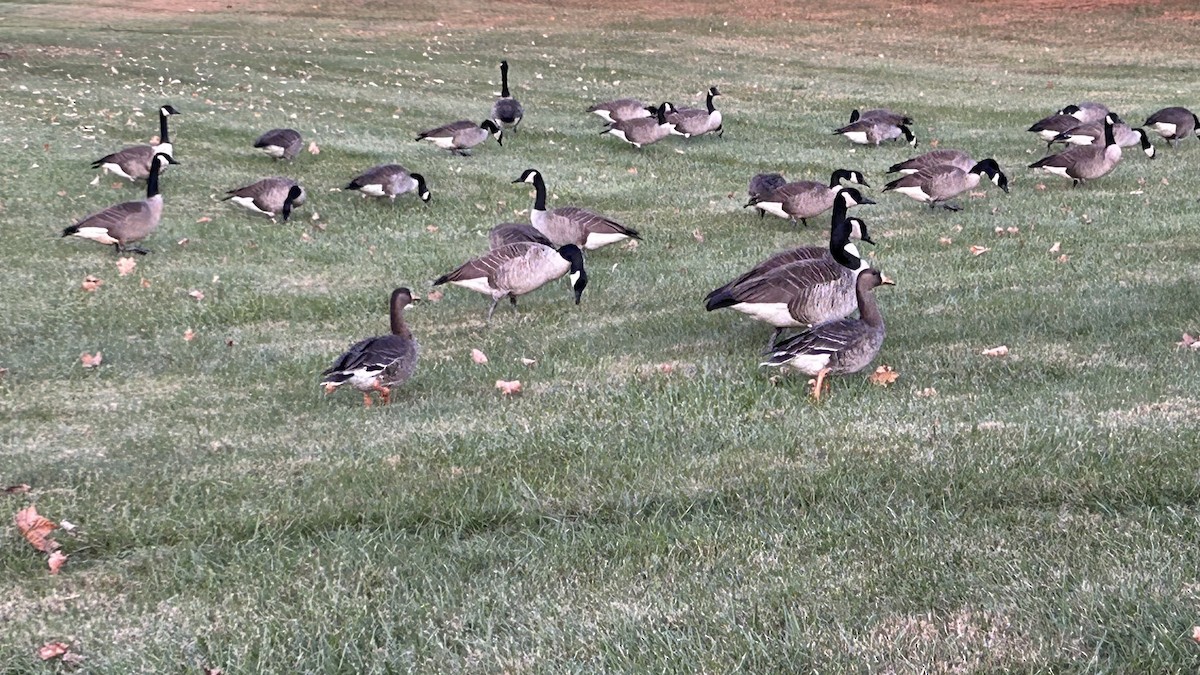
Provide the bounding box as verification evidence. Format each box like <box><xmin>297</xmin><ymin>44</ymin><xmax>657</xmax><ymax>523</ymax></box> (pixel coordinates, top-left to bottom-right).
<box><xmin>761</xmin><ymin>269</ymin><xmax>894</xmax><ymax>401</ymax></box>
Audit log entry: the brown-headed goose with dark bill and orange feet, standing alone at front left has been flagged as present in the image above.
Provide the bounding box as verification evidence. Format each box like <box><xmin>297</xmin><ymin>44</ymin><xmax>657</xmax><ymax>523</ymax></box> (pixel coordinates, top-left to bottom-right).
<box><xmin>320</xmin><ymin>288</ymin><xmax>420</xmax><ymax>407</ymax></box>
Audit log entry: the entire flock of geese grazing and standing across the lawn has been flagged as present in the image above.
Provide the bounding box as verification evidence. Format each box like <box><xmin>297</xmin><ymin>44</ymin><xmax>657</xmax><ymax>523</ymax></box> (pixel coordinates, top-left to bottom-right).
<box><xmin>62</xmin><ymin>60</ymin><xmax>1200</xmax><ymax>406</ymax></box>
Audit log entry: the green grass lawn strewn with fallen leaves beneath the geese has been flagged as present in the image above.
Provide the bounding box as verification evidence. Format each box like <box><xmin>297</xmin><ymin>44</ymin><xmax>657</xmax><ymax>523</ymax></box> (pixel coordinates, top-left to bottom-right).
<box><xmin>0</xmin><ymin>0</ymin><xmax>1200</xmax><ymax>674</ymax></box>
